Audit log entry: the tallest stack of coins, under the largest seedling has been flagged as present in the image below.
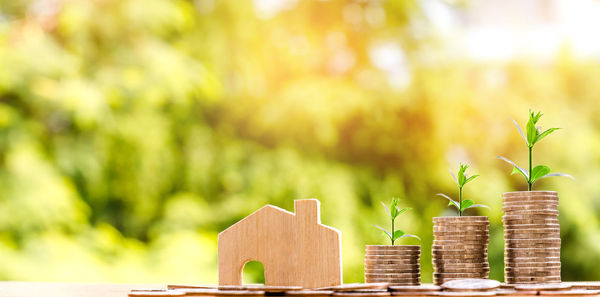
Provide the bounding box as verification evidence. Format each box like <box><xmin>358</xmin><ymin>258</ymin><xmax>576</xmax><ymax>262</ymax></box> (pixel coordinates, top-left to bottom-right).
<box><xmin>502</xmin><ymin>191</ymin><xmax>561</xmax><ymax>284</ymax></box>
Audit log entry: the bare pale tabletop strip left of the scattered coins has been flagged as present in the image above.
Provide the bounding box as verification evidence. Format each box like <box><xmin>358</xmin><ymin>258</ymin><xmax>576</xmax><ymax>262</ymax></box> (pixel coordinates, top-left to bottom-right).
<box><xmin>0</xmin><ymin>282</ymin><xmax>167</xmax><ymax>297</ymax></box>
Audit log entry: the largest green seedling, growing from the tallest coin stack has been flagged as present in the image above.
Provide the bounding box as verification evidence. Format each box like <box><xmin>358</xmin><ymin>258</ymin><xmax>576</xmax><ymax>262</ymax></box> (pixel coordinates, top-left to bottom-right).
<box><xmin>498</xmin><ymin>110</ymin><xmax>574</xmax><ymax>191</ymax></box>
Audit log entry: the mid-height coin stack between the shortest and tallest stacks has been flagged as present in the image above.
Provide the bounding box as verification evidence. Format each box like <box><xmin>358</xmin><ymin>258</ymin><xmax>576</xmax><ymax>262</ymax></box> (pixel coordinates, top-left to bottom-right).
<box><xmin>432</xmin><ymin>216</ymin><xmax>490</xmax><ymax>285</ymax></box>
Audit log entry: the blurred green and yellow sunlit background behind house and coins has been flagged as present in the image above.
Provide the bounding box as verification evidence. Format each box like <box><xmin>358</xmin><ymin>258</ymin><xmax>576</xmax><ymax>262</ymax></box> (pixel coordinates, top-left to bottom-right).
<box><xmin>0</xmin><ymin>0</ymin><xmax>600</xmax><ymax>283</ymax></box>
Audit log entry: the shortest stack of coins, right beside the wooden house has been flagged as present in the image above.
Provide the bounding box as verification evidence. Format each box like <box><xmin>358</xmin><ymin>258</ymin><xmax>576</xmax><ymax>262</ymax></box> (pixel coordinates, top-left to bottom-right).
<box><xmin>365</xmin><ymin>245</ymin><xmax>421</xmax><ymax>285</ymax></box>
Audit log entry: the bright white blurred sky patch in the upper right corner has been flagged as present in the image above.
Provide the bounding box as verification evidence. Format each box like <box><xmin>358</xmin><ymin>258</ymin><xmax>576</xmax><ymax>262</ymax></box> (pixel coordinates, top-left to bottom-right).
<box><xmin>421</xmin><ymin>0</ymin><xmax>600</xmax><ymax>61</ymax></box>
